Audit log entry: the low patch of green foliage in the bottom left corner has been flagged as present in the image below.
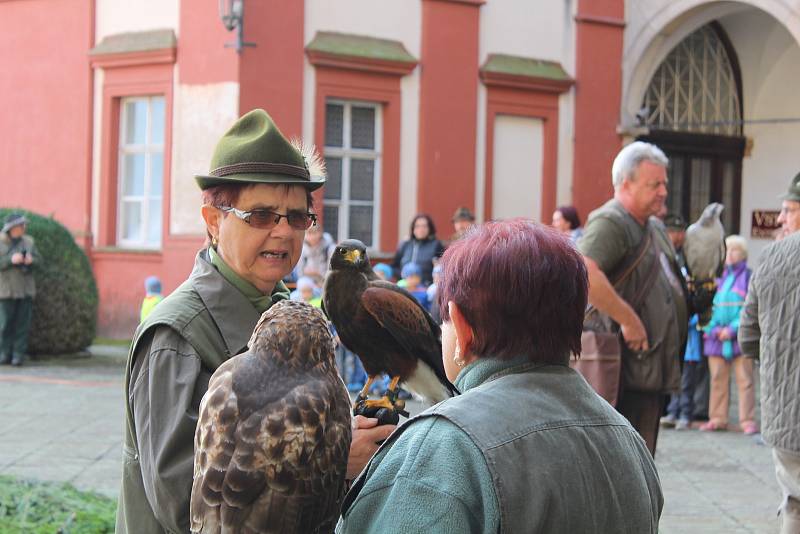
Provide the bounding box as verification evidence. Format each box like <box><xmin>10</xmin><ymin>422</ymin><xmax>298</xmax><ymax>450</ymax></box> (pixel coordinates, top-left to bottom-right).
<box><xmin>0</xmin><ymin>476</ymin><xmax>117</xmax><ymax>534</ymax></box>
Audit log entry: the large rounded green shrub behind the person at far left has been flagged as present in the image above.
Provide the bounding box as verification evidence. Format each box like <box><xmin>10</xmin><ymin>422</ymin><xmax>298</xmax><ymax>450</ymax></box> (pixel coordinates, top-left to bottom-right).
<box><xmin>0</xmin><ymin>208</ymin><xmax>98</xmax><ymax>354</ymax></box>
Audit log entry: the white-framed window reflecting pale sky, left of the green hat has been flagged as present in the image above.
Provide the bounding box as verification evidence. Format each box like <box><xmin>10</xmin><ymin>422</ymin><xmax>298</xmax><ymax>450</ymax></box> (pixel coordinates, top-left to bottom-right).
<box><xmin>117</xmin><ymin>96</ymin><xmax>166</xmax><ymax>248</ymax></box>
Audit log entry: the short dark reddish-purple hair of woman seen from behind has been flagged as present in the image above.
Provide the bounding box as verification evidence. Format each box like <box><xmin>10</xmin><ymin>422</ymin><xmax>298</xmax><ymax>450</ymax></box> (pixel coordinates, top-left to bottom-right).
<box><xmin>438</xmin><ymin>219</ymin><xmax>588</xmax><ymax>365</ymax></box>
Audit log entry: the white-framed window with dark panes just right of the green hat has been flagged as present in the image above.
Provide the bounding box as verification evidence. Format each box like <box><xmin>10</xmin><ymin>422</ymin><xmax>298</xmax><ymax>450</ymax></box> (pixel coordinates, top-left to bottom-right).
<box><xmin>323</xmin><ymin>100</ymin><xmax>381</xmax><ymax>247</ymax></box>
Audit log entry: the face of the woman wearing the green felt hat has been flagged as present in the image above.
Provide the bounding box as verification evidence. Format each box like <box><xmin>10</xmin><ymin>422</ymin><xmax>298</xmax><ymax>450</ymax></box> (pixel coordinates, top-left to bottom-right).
<box><xmin>212</xmin><ymin>184</ymin><xmax>308</xmax><ymax>294</ymax></box>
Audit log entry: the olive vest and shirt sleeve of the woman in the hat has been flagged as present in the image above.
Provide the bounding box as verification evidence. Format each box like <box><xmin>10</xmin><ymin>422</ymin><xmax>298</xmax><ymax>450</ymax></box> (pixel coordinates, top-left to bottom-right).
<box><xmin>116</xmin><ymin>250</ymin><xmax>286</xmax><ymax>534</ymax></box>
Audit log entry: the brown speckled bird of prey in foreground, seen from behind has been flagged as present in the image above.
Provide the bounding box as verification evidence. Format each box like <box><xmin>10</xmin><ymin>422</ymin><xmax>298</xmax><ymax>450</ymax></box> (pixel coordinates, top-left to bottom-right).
<box><xmin>191</xmin><ymin>301</ymin><xmax>351</xmax><ymax>533</ymax></box>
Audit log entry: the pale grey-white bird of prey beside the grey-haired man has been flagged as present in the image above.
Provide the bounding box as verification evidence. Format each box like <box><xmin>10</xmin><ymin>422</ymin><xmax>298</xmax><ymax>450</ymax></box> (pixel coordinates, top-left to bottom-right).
<box><xmin>683</xmin><ymin>202</ymin><xmax>725</xmax><ymax>325</ymax></box>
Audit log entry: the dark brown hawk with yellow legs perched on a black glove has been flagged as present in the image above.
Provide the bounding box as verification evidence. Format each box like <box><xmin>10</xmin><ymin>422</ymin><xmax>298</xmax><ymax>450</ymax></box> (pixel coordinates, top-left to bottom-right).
<box><xmin>322</xmin><ymin>239</ymin><xmax>458</xmax><ymax>422</ymax></box>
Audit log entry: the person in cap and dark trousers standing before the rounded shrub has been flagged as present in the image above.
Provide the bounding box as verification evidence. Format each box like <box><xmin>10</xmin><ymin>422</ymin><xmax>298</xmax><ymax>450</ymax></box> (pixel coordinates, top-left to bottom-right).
<box><xmin>0</xmin><ymin>213</ymin><xmax>39</xmax><ymax>366</ymax></box>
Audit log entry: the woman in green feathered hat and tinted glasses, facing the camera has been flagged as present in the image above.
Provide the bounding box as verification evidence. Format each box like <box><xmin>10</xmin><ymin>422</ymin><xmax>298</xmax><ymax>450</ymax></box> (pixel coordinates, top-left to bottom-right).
<box><xmin>117</xmin><ymin>109</ymin><xmax>392</xmax><ymax>533</ymax></box>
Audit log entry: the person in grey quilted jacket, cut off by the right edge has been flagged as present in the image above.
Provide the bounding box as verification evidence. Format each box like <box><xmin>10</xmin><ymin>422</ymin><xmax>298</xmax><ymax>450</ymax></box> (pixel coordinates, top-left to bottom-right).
<box><xmin>738</xmin><ymin>174</ymin><xmax>800</xmax><ymax>534</ymax></box>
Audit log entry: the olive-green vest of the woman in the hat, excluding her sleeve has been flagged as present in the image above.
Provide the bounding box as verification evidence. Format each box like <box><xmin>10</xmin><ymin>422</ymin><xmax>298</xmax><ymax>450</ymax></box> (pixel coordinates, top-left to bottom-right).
<box><xmin>116</xmin><ymin>250</ymin><xmax>280</xmax><ymax>534</ymax></box>
